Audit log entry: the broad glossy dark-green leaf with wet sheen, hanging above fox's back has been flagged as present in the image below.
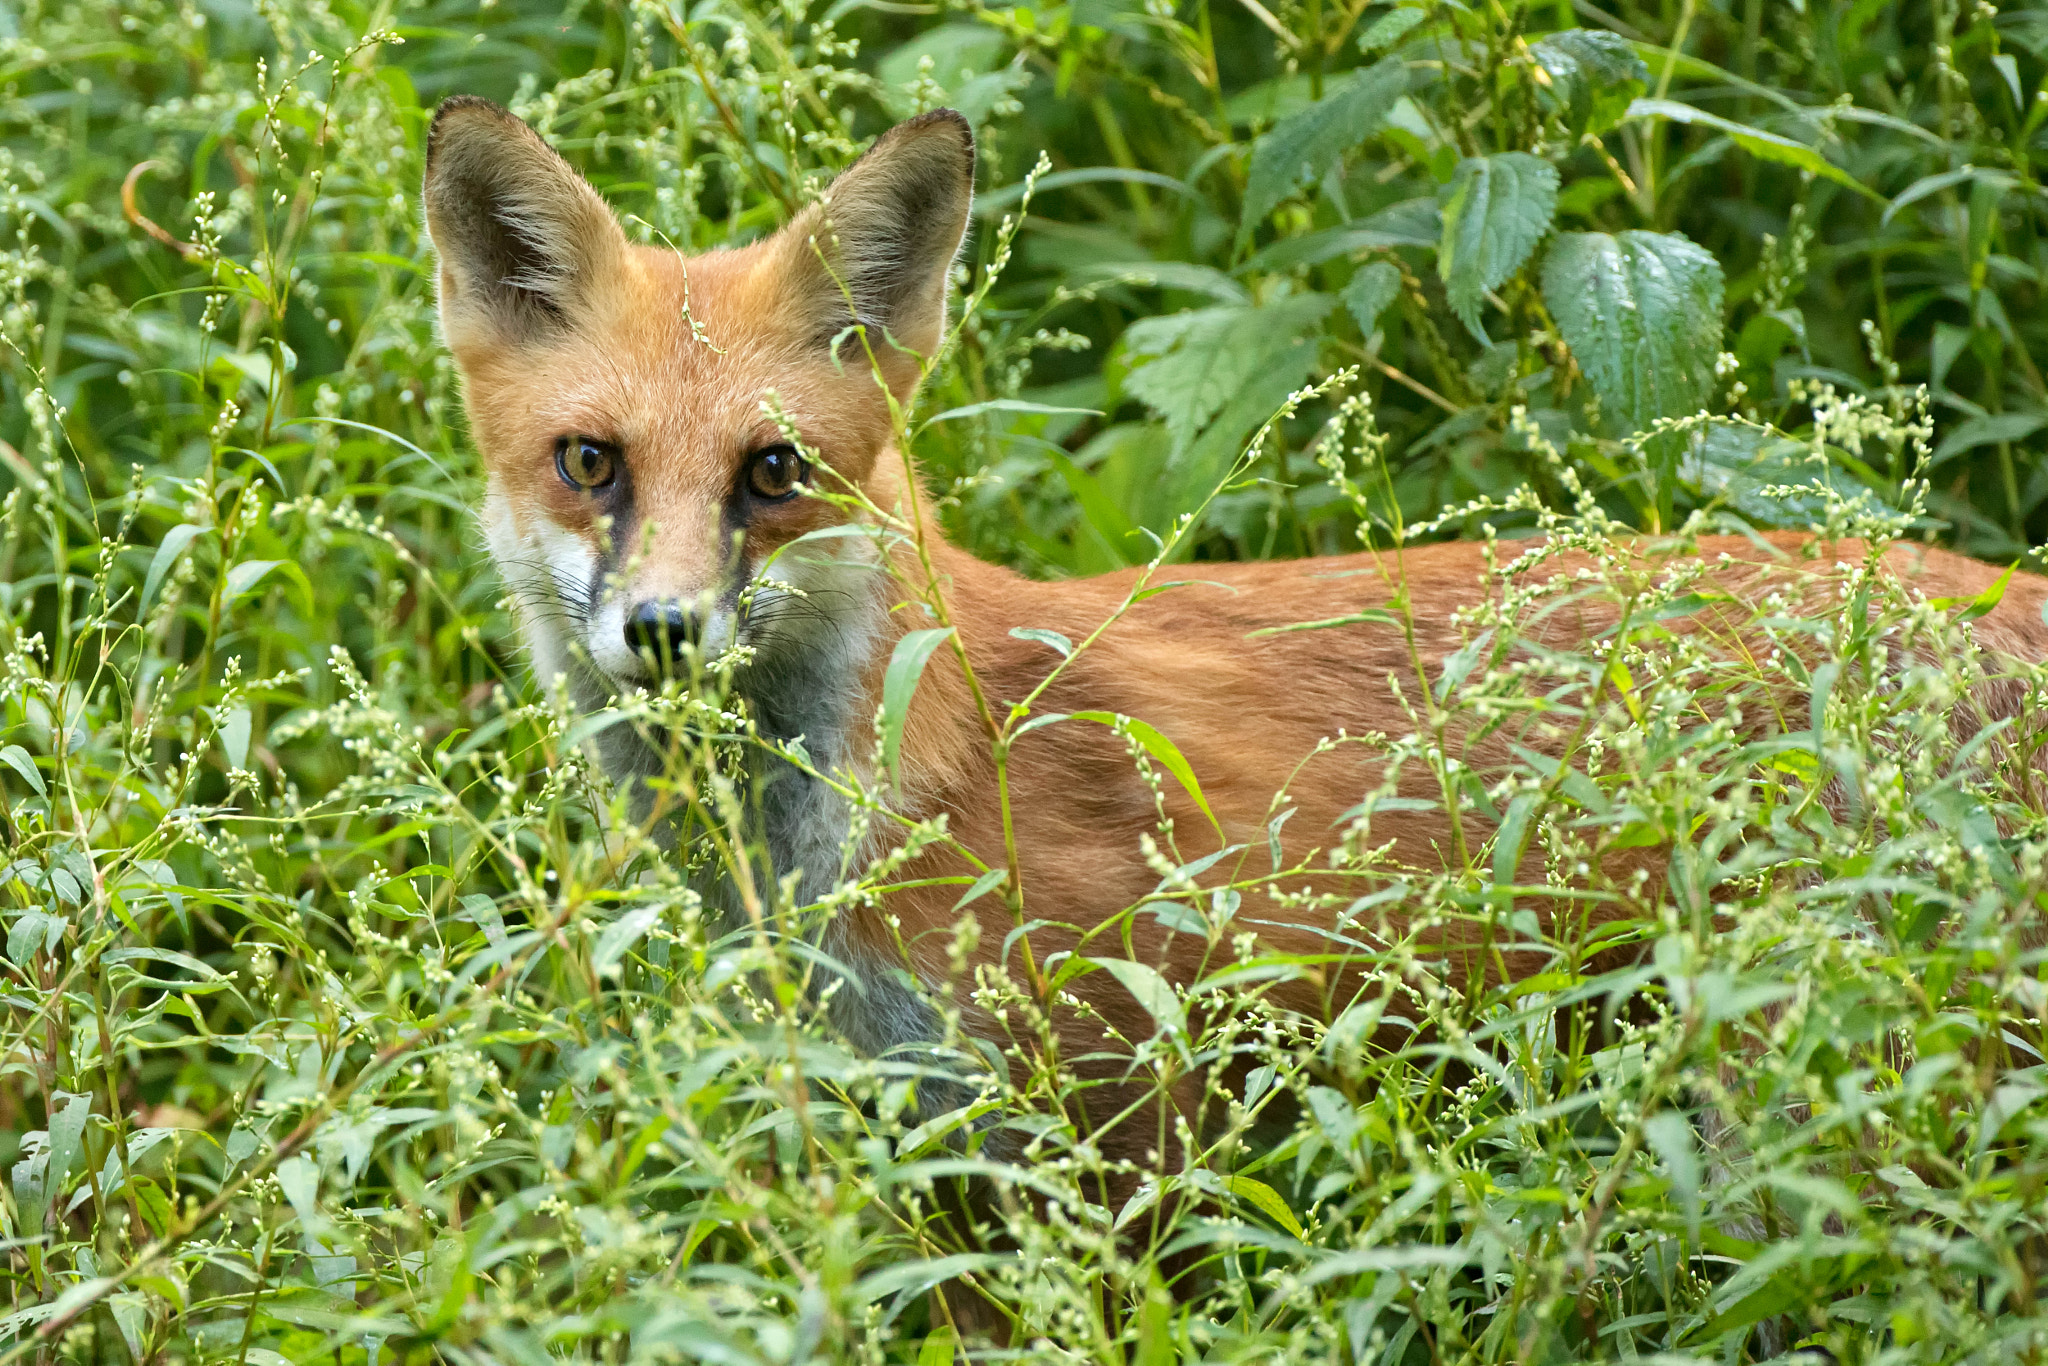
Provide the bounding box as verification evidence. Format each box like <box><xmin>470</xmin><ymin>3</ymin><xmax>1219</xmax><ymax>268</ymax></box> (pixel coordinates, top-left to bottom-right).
<box><xmin>1542</xmin><ymin>231</ymin><xmax>1720</xmax><ymax>436</ymax></box>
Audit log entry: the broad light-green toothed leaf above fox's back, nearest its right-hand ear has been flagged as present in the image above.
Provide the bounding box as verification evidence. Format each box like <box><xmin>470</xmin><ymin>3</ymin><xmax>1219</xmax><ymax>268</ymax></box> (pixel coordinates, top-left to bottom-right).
<box><xmin>1124</xmin><ymin>295</ymin><xmax>1337</xmax><ymax>451</ymax></box>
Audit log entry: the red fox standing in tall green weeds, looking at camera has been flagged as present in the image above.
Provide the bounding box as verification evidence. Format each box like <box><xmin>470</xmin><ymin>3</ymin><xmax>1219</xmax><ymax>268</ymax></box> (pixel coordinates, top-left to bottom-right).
<box><xmin>424</xmin><ymin>98</ymin><xmax>2048</xmax><ymax>1157</ymax></box>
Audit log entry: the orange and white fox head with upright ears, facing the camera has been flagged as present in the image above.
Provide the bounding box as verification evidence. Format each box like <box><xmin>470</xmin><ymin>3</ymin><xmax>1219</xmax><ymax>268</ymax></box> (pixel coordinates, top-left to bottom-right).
<box><xmin>424</xmin><ymin>98</ymin><xmax>975</xmax><ymax>688</ymax></box>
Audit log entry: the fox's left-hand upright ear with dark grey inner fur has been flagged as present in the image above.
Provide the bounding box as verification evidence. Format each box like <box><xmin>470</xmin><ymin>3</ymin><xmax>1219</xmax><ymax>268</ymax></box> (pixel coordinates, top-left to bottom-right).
<box><xmin>424</xmin><ymin>94</ymin><xmax>627</xmax><ymax>344</ymax></box>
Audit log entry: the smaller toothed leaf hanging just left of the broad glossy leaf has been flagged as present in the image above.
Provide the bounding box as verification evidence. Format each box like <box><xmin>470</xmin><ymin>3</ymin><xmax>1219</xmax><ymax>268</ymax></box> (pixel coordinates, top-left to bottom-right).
<box><xmin>1436</xmin><ymin>152</ymin><xmax>1556</xmax><ymax>342</ymax></box>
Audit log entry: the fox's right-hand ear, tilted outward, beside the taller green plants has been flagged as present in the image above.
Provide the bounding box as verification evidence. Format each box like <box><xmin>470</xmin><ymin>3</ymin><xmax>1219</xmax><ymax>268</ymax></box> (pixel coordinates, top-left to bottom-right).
<box><xmin>782</xmin><ymin>109</ymin><xmax>975</xmax><ymax>371</ymax></box>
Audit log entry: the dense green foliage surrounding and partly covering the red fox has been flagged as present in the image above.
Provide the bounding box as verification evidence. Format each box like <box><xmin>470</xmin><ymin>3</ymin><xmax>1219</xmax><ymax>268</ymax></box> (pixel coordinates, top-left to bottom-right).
<box><xmin>0</xmin><ymin>0</ymin><xmax>2048</xmax><ymax>1366</ymax></box>
